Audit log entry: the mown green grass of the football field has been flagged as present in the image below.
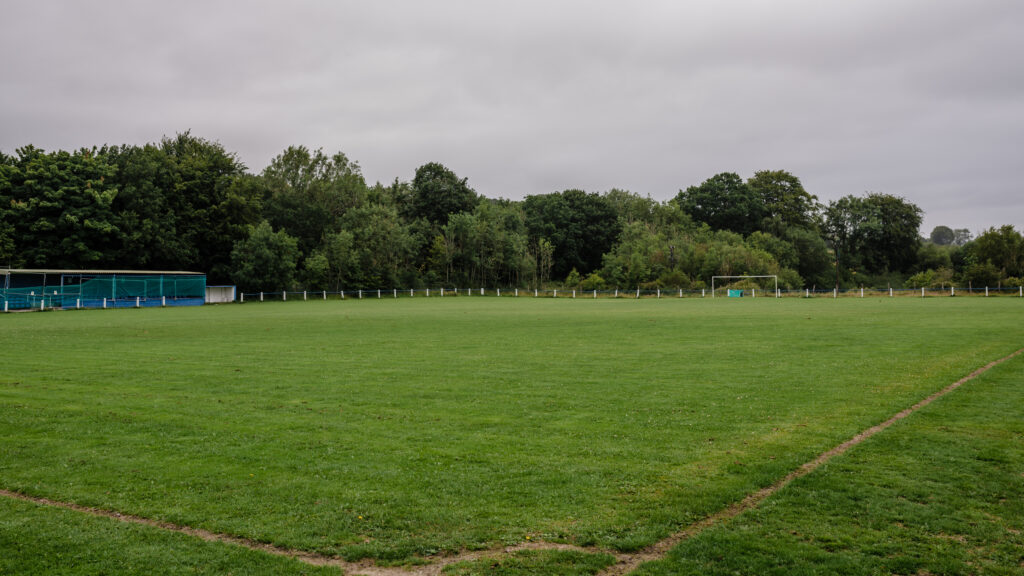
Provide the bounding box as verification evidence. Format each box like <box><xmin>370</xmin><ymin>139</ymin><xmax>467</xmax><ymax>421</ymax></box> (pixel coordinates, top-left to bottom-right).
<box><xmin>0</xmin><ymin>297</ymin><xmax>1024</xmax><ymax>575</ymax></box>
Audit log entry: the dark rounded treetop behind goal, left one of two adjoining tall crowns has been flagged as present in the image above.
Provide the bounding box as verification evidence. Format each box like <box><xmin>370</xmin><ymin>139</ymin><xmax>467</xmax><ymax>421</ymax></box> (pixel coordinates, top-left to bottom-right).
<box><xmin>675</xmin><ymin>172</ymin><xmax>765</xmax><ymax>236</ymax></box>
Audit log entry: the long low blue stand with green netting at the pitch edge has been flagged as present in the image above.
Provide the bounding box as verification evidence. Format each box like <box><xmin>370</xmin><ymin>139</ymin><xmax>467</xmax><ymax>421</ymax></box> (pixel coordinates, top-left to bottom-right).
<box><xmin>0</xmin><ymin>269</ymin><xmax>206</xmax><ymax>310</ymax></box>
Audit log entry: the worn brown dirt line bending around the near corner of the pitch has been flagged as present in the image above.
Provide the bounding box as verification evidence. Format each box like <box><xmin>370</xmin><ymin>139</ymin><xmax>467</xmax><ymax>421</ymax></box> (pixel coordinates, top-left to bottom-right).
<box><xmin>0</xmin><ymin>348</ymin><xmax>1024</xmax><ymax>576</ymax></box>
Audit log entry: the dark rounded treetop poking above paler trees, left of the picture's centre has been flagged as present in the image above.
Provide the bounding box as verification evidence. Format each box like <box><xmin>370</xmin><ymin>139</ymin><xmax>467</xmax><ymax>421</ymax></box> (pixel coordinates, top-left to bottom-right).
<box><xmin>409</xmin><ymin>162</ymin><xmax>478</xmax><ymax>228</ymax></box>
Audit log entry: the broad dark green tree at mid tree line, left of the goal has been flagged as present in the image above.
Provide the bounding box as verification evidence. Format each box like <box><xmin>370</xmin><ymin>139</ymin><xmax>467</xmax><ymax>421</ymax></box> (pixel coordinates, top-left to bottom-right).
<box><xmin>522</xmin><ymin>190</ymin><xmax>622</xmax><ymax>278</ymax></box>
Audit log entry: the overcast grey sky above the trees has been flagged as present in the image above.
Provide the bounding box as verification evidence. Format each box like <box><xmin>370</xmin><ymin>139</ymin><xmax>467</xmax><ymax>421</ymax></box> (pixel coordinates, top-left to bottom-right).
<box><xmin>0</xmin><ymin>0</ymin><xmax>1024</xmax><ymax>235</ymax></box>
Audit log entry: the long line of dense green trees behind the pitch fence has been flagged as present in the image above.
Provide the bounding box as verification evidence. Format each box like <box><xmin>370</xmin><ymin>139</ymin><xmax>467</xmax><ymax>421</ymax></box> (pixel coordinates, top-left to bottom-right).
<box><xmin>0</xmin><ymin>132</ymin><xmax>1024</xmax><ymax>291</ymax></box>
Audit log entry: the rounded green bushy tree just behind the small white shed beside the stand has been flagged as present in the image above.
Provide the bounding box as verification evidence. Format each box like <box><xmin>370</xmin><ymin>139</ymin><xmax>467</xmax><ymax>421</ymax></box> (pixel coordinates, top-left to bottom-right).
<box><xmin>231</xmin><ymin>220</ymin><xmax>299</xmax><ymax>292</ymax></box>
